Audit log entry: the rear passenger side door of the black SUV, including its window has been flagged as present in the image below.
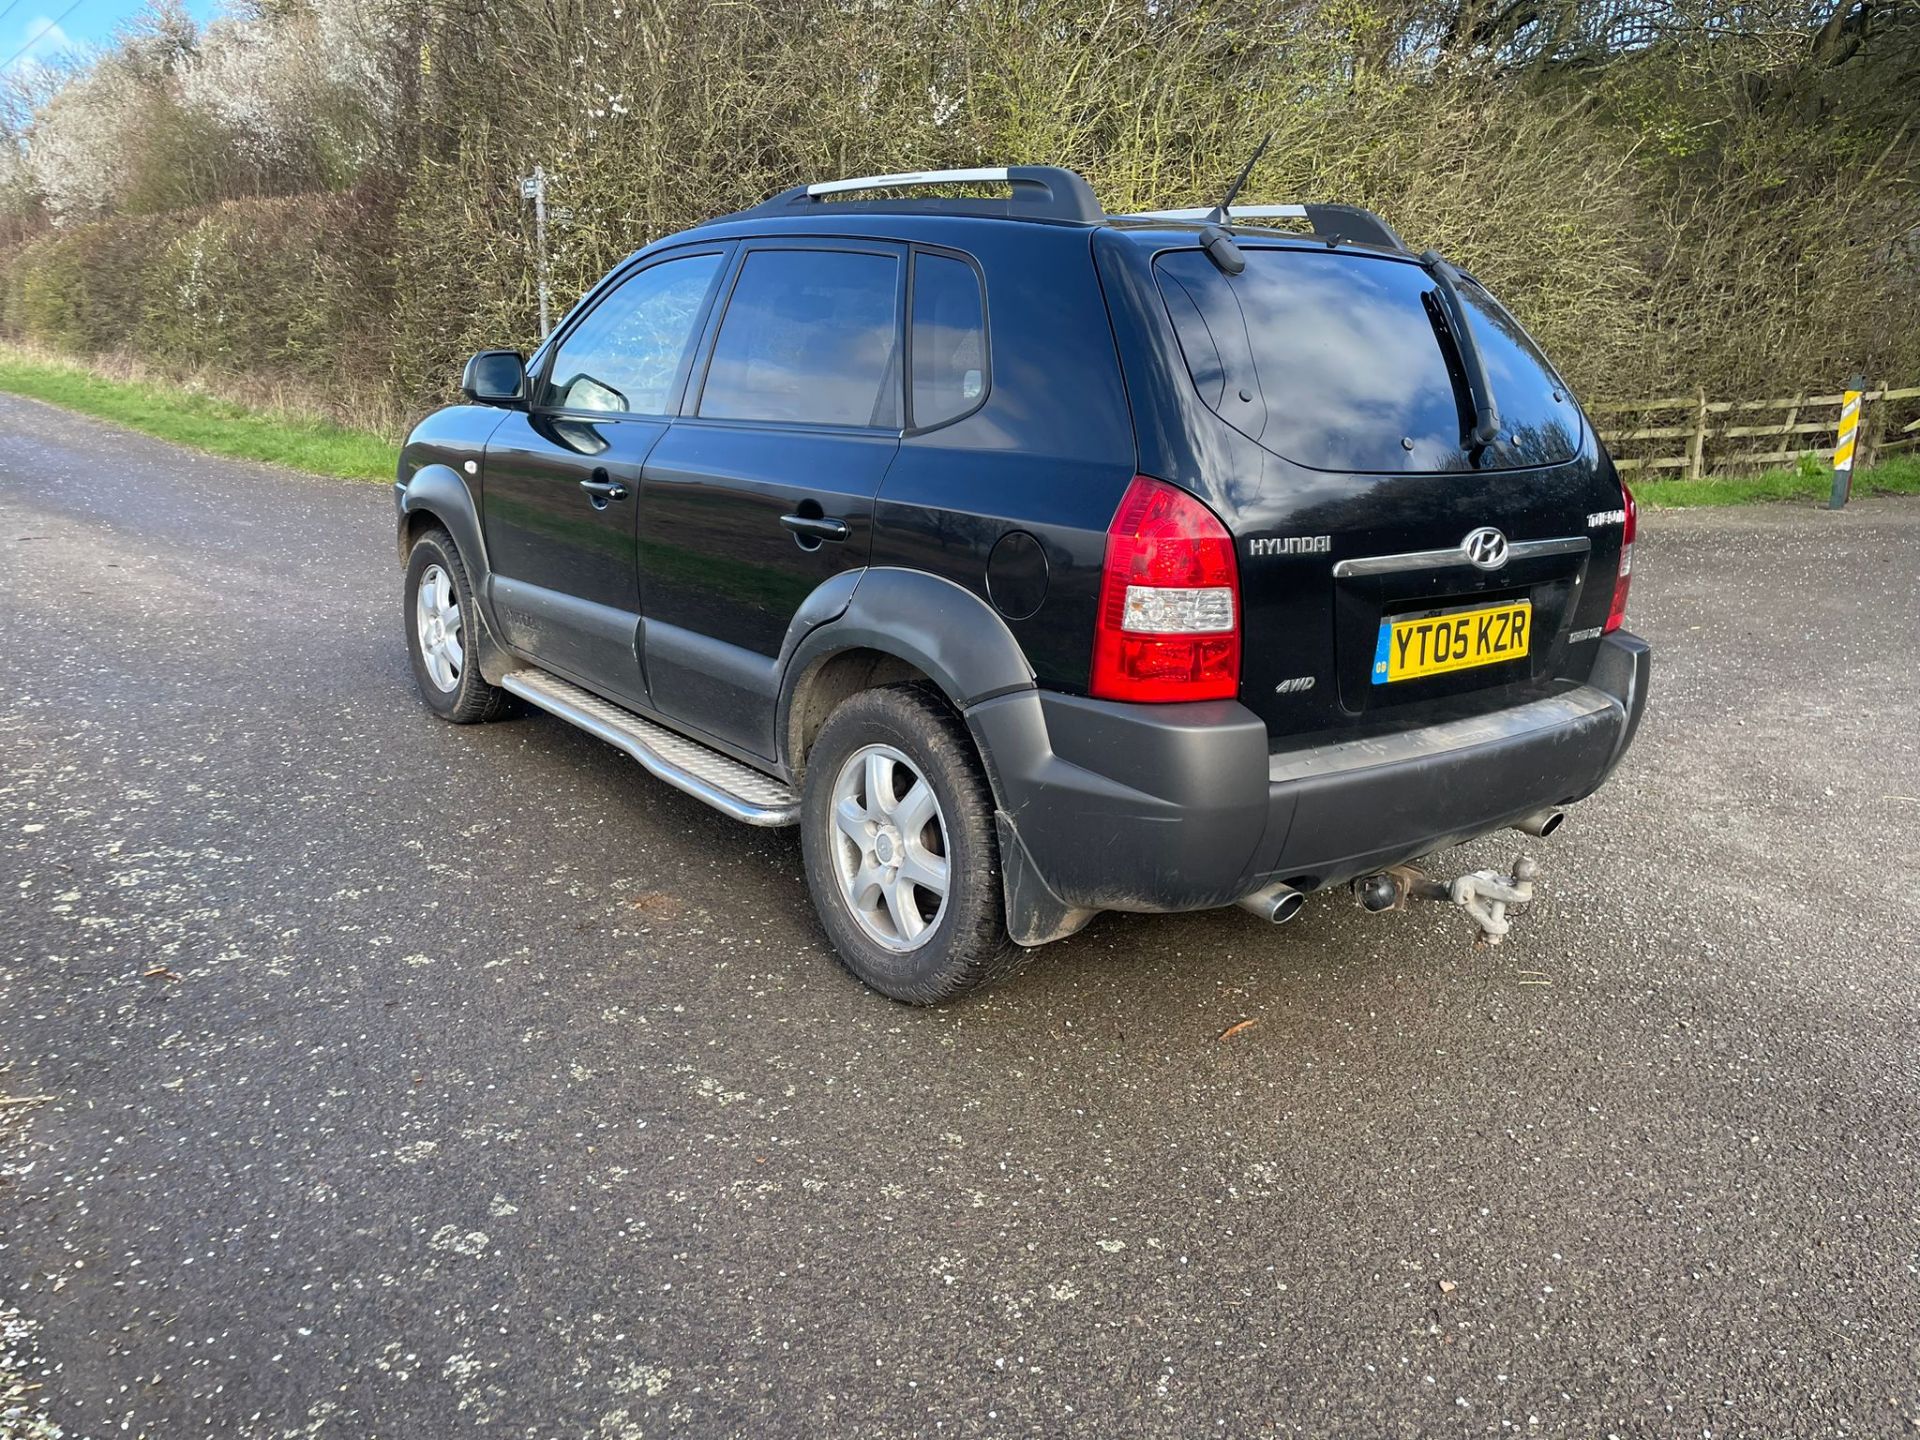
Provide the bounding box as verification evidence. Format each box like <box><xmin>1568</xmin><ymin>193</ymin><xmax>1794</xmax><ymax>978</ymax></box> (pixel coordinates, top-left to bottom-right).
<box><xmin>639</xmin><ymin>240</ymin><xmax>906</xmax><ymax>756</ymax></box>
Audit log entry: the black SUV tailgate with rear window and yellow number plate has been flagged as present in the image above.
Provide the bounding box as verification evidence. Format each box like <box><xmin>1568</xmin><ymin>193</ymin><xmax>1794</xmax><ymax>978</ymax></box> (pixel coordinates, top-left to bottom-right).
<box><xmin>1128</xmin><ymin>244</ymin><xmax>1619</xmax><ymax>735</ymax></box>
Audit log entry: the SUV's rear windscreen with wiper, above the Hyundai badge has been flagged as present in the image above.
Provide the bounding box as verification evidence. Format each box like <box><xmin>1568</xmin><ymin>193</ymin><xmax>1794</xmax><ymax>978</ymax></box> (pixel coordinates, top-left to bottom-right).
<box><xmin>1154</xmin><ymin>246</ymin><xmax>1580</xmax><ymax>470</ymax></box>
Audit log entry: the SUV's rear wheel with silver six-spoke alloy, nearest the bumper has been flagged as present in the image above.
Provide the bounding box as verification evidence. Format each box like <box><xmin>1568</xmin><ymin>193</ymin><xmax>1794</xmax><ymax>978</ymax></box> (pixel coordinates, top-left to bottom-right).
<box><xmin>801</xmin><ymin>685</ymin><xmax>1025</xmax><ymax>1004</ymax></box>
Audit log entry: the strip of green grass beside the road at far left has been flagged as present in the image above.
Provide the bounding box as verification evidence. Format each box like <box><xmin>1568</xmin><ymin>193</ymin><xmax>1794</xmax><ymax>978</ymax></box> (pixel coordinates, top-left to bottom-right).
<box><xmin>0</xmin><ymin>348</ymin><xmax>399</xmax><ymax>480</ymax></box>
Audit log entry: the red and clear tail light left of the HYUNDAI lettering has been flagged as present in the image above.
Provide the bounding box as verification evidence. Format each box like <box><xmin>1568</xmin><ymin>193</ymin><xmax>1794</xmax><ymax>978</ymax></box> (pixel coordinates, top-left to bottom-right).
<box><xmin>1089</xmin><ymin>474</ymin><xmax>1240</xmax><ymax>701</ymax></box>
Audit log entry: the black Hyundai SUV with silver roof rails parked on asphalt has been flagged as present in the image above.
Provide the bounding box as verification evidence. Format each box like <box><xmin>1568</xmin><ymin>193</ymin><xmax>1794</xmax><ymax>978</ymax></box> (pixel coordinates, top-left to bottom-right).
<box><xmin>396</xmin><ymin>167</ymin><xmax>1647</xmax><ymax>1002</ymax></box>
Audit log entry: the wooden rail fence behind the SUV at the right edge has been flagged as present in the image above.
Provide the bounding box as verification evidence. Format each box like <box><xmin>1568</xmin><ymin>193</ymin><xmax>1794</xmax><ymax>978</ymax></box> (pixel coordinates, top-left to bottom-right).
<box><xmin>1588</xmin><ymin>380</ymin><xmax>1920</xmax><ymax>480</ymax></box>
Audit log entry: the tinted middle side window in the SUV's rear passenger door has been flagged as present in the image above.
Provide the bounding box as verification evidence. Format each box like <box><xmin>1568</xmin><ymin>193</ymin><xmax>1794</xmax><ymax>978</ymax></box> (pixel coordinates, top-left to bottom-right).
<box><xmin>701</xmin><ymin>250</ymin><xmax>900</xmax><ymax>428</ymax></box>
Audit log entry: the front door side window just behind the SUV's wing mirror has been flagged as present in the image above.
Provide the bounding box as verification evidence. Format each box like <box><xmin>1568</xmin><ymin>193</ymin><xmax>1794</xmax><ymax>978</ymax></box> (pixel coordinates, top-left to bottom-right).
<box><xmin>545</xmin><ymin>255</ymin><xmax>724</xmax><ymax>415</ymax></box>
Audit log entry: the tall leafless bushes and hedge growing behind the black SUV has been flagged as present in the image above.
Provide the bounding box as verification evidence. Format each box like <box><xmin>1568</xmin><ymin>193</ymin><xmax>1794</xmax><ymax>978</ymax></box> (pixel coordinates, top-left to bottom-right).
<box><xmin>0</xmin><ymin>0</ymin><xmax>1920</xmax><ymax>428</ymax></box>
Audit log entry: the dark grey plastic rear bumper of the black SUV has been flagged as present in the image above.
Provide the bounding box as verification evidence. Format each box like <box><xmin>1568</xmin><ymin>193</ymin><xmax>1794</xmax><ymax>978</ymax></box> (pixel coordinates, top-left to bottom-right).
<box><xmin>968</xmin><ymin>632</ymin><xmax>1649</xmax><ymax>945</ymax></box>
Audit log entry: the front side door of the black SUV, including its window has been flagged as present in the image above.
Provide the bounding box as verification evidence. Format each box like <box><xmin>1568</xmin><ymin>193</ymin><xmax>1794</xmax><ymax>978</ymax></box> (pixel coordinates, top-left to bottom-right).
<box><xmin>480</xmin><ymin>246</ymin><xmax>728</xmax><ymax>703</ymax></box>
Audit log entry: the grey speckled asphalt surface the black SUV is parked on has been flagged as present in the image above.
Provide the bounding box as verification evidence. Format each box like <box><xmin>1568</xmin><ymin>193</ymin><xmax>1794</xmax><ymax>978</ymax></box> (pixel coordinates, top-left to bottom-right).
<box><xmin>0</xmin><ymin>385</ymin><xmax>1920</xmax><ymax>1440</ymax></box>
